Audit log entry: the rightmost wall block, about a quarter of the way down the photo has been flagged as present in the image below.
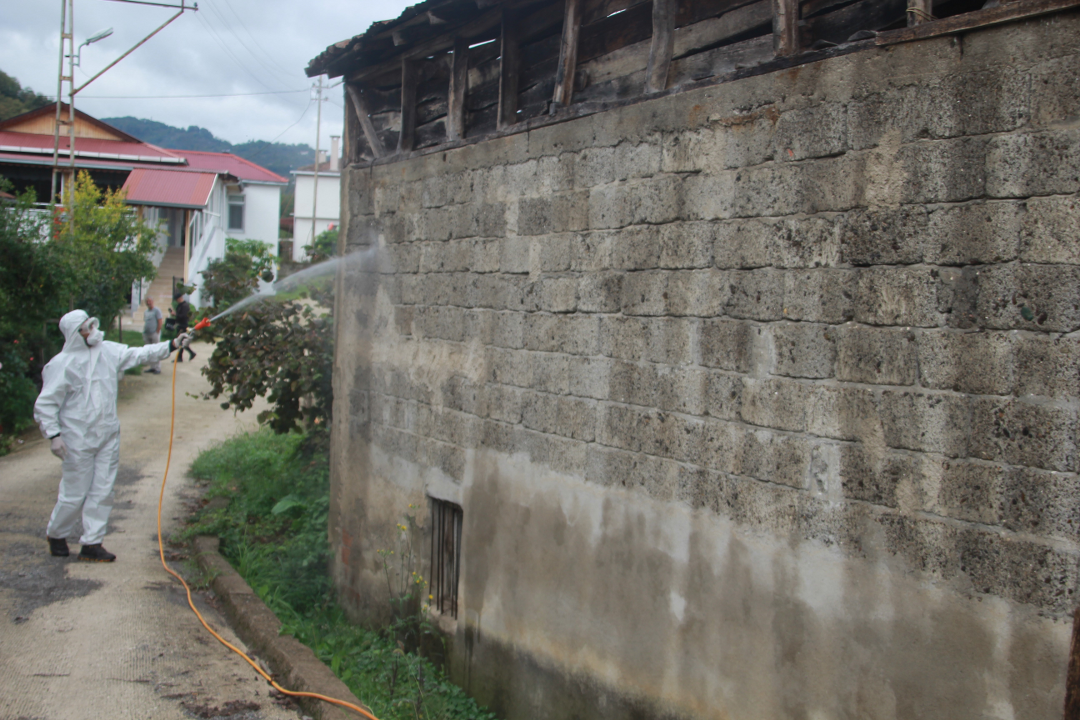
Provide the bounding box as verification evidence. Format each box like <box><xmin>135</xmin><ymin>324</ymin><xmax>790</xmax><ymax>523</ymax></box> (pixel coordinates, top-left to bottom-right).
<box><xmin>986</xmin><ymin>130</ymin><xmax>1080</xmax><ymax>198</ymax></box>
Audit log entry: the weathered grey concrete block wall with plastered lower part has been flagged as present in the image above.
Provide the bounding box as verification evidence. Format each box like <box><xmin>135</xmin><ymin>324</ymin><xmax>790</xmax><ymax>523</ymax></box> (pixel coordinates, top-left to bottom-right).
<box><xmin>330</xmin><ymin>13</ymin><xmax>1080</xmax><ymax>720</ymax></box>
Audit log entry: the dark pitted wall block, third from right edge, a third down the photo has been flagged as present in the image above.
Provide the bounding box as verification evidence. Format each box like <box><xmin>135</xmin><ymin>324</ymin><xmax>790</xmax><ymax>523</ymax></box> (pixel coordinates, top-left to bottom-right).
<box><xmin>840</xmin><ymin>205</ymin><xmax>928</xmax><ymax>266</ymax></box>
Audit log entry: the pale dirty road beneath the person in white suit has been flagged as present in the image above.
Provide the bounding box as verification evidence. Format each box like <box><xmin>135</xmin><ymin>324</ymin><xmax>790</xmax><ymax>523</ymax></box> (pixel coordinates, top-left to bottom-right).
<box><xmin>0</xmin><ymin>344</ymin><xmax>300</xmax><ymax>720</ymax></box>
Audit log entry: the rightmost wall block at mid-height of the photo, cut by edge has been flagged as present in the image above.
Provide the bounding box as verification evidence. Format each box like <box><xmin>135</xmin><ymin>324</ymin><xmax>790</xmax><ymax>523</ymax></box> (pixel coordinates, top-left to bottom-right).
<box><xmin>1014</xmin><ymin>332</ymin><xmax>1080</xmax><ymax>399</ymax></box>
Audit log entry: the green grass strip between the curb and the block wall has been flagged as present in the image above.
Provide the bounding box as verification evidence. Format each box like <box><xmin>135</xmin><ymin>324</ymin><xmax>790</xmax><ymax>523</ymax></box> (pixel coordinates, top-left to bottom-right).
<box><xmin>184</xmin><ymin>430</ymin><xmax>495</xmax><ymax>720</ymax></box>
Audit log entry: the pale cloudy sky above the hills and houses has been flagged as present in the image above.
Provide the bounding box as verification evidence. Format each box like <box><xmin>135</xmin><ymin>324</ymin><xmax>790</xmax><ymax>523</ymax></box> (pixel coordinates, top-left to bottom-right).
<box><xmin>0</xmin><ymin>0</ymin><xmax>417</xmax><ymax>147</ymax></box>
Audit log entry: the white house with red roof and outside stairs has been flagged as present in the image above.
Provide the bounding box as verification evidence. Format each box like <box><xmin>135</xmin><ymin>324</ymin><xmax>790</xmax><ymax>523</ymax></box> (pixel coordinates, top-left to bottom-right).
<box><xmin>0</xmin><ymin>105</ymin><xmax>287</xmax><ymax>310</ymax></box>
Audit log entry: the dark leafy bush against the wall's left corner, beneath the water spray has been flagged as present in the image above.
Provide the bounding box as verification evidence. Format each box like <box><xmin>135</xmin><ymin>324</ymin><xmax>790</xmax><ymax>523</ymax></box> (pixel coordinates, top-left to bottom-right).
<box><xmin>203</xmin><ymin>295</ymin><xmax>334</xmax><ymax>441</ymax></box>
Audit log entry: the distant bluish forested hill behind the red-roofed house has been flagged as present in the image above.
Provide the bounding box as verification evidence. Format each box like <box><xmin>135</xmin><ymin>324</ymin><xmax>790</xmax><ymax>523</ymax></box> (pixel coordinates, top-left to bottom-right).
<box><xmin>102</xmin><ymin>117</ymin><xmax>315</xmax><ymax>179</ymax></box>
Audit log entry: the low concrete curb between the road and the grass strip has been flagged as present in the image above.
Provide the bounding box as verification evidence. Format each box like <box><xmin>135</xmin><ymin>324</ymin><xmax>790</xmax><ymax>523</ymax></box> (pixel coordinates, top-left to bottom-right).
<box><xmin>194</xmin><ymin>535</ymin><xmax>367</xmax><ymax>720</ymax></box>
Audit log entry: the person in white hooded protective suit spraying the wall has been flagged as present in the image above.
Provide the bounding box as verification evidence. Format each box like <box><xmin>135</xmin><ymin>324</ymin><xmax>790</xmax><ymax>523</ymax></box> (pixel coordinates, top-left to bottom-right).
<box><xmin>33</xmin><ymin>310</ymin><xmax>190</xmax><ymax>562</ymax></box>
